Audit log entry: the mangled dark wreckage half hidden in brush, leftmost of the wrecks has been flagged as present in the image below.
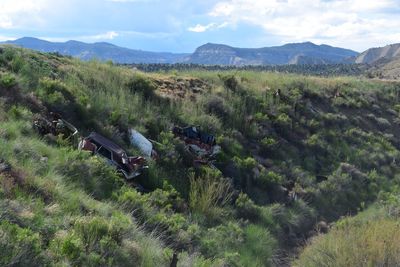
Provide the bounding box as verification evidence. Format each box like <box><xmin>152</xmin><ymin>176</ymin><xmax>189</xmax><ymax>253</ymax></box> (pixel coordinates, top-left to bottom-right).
<box><xmin>33</xmin><ymin>112</ymin><xmax>78</xmax><ymax>139</ymax></box>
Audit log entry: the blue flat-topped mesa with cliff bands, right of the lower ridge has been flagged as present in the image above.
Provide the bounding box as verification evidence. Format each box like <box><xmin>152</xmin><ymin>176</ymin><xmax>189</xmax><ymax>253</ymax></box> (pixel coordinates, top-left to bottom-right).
<box><xmin>187</xmin><ymin>42</ymin><xmax>358</xmax><ymax>65</ymax></box>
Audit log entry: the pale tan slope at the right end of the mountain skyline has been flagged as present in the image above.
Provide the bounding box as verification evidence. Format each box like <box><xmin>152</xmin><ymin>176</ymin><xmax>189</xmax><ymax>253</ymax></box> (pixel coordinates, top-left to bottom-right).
<box><xmin>355</xmin><ymin>44</ymin><xmax>400</xmax><ymax>64</ymax></box>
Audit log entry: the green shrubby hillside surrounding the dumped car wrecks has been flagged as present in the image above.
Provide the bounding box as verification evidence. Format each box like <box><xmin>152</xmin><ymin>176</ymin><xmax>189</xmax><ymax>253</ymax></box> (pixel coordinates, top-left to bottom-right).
<box><xmin>0</xmin><ymin>47</ymin><xmax>400</xmax><ymax>266</ymax></box>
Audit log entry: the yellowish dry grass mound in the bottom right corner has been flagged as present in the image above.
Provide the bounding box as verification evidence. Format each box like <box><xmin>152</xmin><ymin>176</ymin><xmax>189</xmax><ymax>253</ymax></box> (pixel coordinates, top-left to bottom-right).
<box><xmin>294</xmin><ymin>219</ymin><xmax>400</xmax><ymax>267</ymax></box>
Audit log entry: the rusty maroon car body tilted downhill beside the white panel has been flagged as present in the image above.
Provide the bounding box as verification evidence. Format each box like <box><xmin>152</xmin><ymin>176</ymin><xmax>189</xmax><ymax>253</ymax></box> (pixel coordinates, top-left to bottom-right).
<box><xmin>78</xmin><ymin>132</ymin><xmax>149</xmax><ymax>180</ymax></box>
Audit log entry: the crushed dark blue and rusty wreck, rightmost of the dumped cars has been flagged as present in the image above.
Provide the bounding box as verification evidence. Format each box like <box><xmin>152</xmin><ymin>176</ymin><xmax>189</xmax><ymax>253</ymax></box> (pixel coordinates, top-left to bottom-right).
<box><xmin>172</xmin><ymin>126</ymin><xmax>221</xmax><ymax>168</ymax></box>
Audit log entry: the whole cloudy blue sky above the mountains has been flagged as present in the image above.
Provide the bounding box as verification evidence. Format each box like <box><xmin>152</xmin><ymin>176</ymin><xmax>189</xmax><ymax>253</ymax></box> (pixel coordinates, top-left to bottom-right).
<box><xmin>0</xmin><ymin>0</ymin><xmax>400</xmax><ymax>53</ymax></box>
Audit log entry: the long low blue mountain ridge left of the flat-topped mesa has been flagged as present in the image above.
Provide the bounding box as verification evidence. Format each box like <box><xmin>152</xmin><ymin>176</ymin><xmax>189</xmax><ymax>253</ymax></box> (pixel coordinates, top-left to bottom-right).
<box><xmin>2</xmin><ymin>37</ymin><xmax>186</xmax><ymax>63</ymax></box>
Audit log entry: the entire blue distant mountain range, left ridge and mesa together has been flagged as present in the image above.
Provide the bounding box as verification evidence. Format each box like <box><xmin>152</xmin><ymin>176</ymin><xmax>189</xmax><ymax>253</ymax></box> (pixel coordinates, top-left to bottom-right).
<box><xmin>4</xmin><ymin>37</ymin><xmax>359</xmax><ymax>66</ymax></box>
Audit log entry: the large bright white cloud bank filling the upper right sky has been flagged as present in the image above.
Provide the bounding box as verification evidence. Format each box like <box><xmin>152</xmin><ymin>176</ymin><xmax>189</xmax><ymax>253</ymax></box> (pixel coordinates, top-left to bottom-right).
<box><xmin>208</xmin><ymin>0</ymin><xmax>400</xmax><ymax>50</ymax></box>
